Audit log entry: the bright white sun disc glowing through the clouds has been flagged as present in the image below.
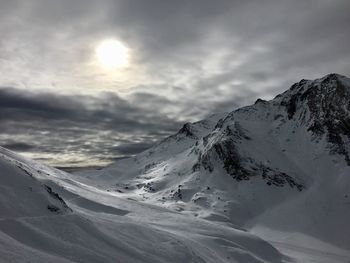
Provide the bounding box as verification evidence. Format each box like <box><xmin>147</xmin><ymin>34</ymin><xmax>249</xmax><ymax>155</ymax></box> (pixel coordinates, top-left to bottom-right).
<box><xmin>95</xmin><ymin>39</ymin><xmax>129</xmax><ymax>69</ymax></box>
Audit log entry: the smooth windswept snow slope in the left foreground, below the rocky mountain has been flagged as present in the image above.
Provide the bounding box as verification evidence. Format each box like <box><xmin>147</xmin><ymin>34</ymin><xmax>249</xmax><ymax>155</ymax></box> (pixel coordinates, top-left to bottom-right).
<box><xmin>0</xmin><ymin>148</ymin><xmax>288</xmax><ymax>262</ymax></box>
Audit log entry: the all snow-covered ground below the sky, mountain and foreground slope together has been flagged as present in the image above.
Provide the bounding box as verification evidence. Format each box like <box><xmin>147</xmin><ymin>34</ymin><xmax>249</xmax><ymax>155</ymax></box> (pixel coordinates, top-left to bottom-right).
<box><xmin>0</xmin><ymin>74</ymin><xmax>350</xmax><ymax>263</ymax></box>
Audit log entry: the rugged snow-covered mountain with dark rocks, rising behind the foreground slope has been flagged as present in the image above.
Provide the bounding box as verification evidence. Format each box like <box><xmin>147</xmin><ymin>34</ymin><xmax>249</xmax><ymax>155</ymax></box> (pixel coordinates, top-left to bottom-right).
<box><xmin>78</xmin><ymin>74</ymin><xmax>350</xmax><ymax>260</ymax></box>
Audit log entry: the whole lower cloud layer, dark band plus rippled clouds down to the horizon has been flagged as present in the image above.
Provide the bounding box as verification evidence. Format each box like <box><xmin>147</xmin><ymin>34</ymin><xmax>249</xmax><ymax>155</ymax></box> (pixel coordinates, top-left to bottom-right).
<box><xmin>0</xmin><ymin>88</ymin><xmax>181</xmax><ymax>165</ymax></box>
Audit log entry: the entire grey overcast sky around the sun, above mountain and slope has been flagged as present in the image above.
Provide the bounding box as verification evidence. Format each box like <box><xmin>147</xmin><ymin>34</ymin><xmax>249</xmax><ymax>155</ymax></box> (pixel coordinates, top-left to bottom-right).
<box><xmin>0</xmin><ymin>0</ymin><xmax>350</xmax><ymax>166</ymax></box>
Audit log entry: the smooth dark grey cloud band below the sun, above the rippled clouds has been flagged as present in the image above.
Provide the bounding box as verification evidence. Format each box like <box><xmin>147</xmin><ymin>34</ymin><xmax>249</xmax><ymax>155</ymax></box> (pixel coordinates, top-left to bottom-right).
<box><xmin>0</xmin><ymin>88</ymin><xmax>177</xmax><ymax>131</ymax></box>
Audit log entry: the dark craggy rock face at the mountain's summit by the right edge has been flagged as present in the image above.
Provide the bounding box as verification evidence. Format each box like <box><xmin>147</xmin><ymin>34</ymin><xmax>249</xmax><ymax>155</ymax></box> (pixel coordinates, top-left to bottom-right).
<box><xmin>281</xmin><ymin>74</ymin><xmax>350</xmax><ymax>165</ymax></box>
